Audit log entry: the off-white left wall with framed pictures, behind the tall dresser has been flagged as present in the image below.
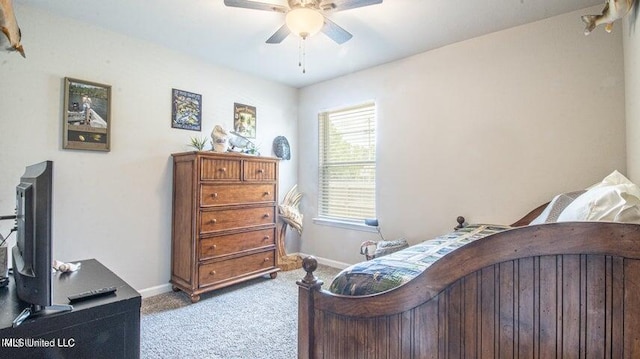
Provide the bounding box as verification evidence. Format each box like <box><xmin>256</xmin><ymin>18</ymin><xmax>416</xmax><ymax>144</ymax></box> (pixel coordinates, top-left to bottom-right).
<box><xmin>0</xmin><ymin>4</ymin><xmax>298</xmax><ymax>289</ymax></box>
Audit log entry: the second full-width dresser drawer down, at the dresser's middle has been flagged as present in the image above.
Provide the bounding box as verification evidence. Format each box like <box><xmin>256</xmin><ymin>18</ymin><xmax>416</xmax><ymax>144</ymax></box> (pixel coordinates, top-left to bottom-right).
<box><xmin>200</xmin><ymin>206</ymin><xmax>276</xmax><ymax>233</ymax></box>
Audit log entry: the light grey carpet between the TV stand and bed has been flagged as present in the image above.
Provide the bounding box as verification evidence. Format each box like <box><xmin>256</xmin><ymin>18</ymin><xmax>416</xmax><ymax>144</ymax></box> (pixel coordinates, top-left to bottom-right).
<box><xmin>140</xmin><ymin>265</ymin><xmax>340</xmax><ymax>359</ymax></box>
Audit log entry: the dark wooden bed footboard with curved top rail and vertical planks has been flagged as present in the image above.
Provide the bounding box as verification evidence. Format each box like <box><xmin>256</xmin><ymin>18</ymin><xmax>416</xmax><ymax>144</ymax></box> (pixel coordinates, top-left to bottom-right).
<box><xmin>298</xmin><ymin>222</ymin><xmax>640</xmax><ymax>359</ymax></box>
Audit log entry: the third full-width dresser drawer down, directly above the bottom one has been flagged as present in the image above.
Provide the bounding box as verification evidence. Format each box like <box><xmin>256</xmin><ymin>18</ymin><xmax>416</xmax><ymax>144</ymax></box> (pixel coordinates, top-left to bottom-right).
<box><xmin>199</xmin><ymin>228</ymin><xmax>276</xmax><ymax>260</ymax></box>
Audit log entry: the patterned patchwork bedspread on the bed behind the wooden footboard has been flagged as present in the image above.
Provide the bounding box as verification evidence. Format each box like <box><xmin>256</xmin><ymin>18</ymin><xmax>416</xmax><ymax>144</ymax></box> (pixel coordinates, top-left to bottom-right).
<box><xmin>329</xmin><ymin>224</ymin><xmax>511</xmax><ymax>295</ymax></box>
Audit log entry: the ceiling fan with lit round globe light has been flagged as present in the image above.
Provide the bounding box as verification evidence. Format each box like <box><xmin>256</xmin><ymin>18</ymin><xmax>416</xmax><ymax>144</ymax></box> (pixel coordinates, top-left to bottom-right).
<box><xmin>224</xmin><ymin>0</ymin><xmax>383</xmax><ymax>44</ymax></box>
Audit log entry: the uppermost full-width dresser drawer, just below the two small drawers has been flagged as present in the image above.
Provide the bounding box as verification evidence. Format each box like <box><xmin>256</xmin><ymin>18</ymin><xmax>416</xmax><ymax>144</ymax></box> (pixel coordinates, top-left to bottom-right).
<box><xmin>200</xmin><ymin>183</ymin><xmax>276</xmax><ymax>207</ymax></box>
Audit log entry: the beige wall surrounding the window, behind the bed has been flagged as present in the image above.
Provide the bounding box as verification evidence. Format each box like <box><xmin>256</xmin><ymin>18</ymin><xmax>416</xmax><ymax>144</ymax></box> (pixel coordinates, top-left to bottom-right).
<box><xmin>298</xmin><ymin>7</ymin><xmax>626</xmax><ymax>263</ymax></box>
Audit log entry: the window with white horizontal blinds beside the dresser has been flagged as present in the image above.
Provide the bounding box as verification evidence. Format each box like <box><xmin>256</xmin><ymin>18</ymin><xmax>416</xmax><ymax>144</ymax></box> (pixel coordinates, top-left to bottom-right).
<box><xmin>318</xmin><ymin>103</ymin><xmax>376</xmax><ymax>223</ymax></box>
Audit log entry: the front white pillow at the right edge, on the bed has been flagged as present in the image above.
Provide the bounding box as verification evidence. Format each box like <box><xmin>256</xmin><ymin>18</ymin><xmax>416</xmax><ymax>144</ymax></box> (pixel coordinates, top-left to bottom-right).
<box><xmin>558</xmin><ymin>171</ymin><xmax>640</xmax><ymax>223</ymax></box>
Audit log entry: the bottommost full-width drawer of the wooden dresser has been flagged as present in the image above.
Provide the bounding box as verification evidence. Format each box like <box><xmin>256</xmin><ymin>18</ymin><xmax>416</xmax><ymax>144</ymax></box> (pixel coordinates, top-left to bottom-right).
<box><xmin>198</xmin><ymin>250</ymin><xmax>275</xmax><ymax>287</ymax></box>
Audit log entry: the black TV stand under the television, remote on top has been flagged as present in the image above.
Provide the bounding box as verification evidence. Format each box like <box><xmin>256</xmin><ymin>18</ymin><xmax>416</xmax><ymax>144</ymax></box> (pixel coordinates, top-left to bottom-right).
<box><xmin>0</xmin><ymin>259</ymin><xmax>141</xmax><ymax>359</ymax></box>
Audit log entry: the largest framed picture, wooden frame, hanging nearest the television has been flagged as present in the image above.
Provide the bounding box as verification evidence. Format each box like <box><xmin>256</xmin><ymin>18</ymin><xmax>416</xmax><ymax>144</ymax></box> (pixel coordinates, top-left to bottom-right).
<box><xmin>62</xmin><ymin>77</ymin><xmax>111</xmax><ymax>151</ymax></box>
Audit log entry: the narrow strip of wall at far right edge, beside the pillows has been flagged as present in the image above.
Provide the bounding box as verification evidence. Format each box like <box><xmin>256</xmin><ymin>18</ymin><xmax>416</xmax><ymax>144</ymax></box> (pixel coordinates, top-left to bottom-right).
<box><xmin>622</xmin><ymin>4</ymin><xmax>640</xmax><ymax>183</ymax></box>
